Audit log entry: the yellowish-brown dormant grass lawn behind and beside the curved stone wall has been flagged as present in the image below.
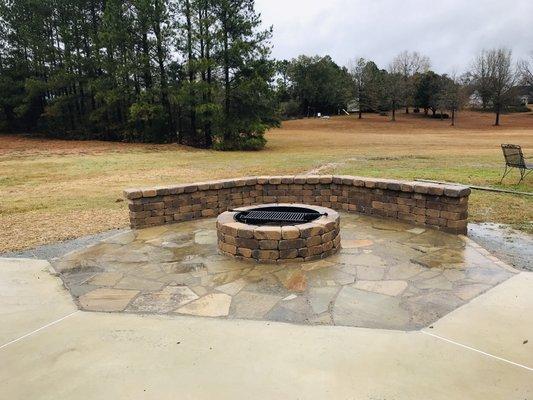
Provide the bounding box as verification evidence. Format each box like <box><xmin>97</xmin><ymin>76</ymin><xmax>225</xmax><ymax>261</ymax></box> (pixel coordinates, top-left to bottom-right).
<box><xmin>0</xmin><ymin>112</ymin><xmax>533</xmax><ymax>253</ymax></box>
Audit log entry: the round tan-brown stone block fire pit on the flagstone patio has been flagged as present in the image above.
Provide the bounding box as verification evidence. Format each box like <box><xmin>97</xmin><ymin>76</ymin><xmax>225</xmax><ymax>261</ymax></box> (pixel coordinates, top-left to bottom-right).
<box><xmin>217</xmin><ymin>204</ymin><xmax>340</xmax><ymax>263</ymax></box>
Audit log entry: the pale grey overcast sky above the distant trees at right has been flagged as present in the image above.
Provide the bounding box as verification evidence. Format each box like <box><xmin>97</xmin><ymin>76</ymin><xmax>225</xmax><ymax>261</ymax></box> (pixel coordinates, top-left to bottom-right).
<box><xmin>256</xmin><ymin>0</ymin><xmax>533</xmax><ymax>73</ymax></box>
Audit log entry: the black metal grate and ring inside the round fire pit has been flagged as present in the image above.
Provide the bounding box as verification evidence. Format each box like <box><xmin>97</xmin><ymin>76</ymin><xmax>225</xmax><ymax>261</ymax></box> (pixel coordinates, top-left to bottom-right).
<box><xmin>235</xmin><ymin>207</ymin><xmax>325</xmax><ymax>225</ymax></box>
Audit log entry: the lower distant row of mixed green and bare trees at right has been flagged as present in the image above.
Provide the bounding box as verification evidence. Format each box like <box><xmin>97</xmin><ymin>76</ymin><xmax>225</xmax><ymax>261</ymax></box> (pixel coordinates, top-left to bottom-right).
<box><xmin>276</xmin><ymin>49</ymin><xmax>533</xmax><ymax>125</ymax></box>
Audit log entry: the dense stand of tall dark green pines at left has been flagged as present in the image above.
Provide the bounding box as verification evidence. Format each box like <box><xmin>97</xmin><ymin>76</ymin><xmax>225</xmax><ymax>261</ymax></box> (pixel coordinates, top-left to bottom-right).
<box><xmin>0</xmin><ymin>0</ymin><xmax>278</xmax><ymax>149</ymax></box>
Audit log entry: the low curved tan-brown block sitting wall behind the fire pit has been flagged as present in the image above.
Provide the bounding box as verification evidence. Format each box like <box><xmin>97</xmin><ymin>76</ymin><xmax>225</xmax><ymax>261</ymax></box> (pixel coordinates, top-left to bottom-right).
<box><xmin>124</xmin><ymin>175</ymin><xmax>470</xmax><ymax>233</ymax></box>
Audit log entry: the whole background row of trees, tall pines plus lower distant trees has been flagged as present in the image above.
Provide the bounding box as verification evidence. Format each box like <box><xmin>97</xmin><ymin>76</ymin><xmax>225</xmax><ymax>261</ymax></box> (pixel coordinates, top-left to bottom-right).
<box><xmin>0</xmin><ymin>0</ymin><xmax>533</xmax><ymax>150</ymax></box>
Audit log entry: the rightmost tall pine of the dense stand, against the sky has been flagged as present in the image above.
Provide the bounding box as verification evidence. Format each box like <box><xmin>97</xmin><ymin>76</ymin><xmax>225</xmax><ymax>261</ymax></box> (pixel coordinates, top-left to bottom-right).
<box><xmin>214</xmin><ymin>0</ymin><xmax>275</xmax><ymax>149</ymax></box>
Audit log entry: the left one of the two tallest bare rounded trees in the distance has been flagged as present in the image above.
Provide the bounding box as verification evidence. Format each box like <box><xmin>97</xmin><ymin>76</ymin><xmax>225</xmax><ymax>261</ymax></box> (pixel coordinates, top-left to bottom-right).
<box><xmin>389</xmin><ymin>50</ymin><xmax>431</xmax><ymax>114</ymax></box>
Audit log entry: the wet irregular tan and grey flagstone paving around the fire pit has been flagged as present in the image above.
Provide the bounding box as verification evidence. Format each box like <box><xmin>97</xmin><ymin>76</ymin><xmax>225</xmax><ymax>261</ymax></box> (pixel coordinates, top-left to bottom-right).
<box><xmin>54</xmin><ymin>214</ymin><xmax>513</xmax><ymax>330</ymax></box>
